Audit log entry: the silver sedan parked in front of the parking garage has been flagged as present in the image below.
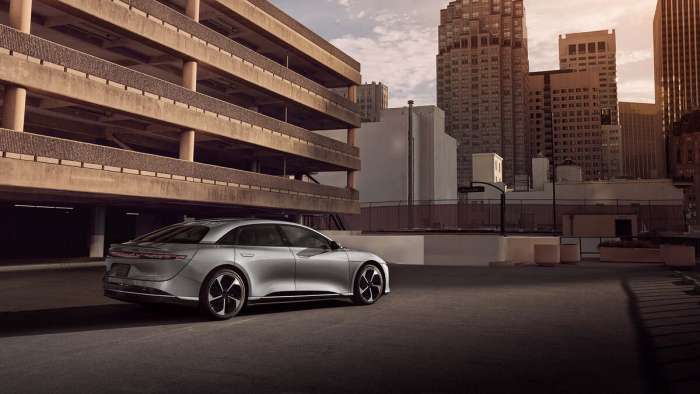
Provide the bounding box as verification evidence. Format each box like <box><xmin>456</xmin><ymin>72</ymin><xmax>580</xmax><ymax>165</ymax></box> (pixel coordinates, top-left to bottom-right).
<box><xmin>103</xmin><ymin>219</ymin><xmax>389</xmax><ymax>320</ymax></box>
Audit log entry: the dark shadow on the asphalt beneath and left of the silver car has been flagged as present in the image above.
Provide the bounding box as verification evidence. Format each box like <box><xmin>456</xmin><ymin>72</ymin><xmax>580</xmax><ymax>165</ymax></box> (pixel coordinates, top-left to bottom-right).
<box><xmin>0</xmin><ymin>301</ymin><xmax>351</xmax><ymax>338</ymax></box>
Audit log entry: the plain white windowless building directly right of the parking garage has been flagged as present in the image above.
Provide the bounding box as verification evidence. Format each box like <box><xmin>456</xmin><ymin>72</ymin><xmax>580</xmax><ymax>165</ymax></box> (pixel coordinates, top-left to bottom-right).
<box><xmin>314</xmin><ymin>106</ymin><xmax>457</xmax><ymax>203</ymax></box>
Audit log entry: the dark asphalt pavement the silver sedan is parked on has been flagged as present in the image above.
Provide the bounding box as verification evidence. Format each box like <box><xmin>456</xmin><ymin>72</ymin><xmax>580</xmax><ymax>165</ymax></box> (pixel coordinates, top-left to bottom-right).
<box><xmin>0</xmin><ymin>264</ymin><xmax>700</xmax><ymax>394</ymax></box>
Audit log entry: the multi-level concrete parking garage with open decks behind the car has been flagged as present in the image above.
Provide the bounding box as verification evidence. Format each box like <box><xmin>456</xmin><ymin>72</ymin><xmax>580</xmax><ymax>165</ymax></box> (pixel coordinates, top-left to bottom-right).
<box><xmin>0</xmin><ymin>0</ymin><xmax>362</xmax><ymax>257</ymax></box>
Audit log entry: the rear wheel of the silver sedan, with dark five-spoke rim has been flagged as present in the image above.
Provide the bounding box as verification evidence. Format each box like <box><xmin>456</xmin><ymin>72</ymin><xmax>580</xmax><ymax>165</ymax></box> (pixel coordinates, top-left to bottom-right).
<box><xmin>199</xmin><ymin>268</ymin><xmax>247</xmax><ymax>320</ymax></box>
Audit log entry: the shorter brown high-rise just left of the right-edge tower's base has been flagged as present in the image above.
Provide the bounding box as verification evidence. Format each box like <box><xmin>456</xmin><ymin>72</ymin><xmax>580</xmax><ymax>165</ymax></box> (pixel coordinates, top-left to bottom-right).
<box><xmin>619</xmin><ymin>102</ymin><xmax>666</xmax><ymax>179</ymax></box>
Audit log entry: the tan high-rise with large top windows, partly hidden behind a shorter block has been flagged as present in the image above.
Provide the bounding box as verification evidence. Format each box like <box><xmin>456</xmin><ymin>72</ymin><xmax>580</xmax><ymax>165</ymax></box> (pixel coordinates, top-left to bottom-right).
<box><xmin>559</xmin><ymin>30</ymin><xmax>622</xmax><ymax>179</ymax></box>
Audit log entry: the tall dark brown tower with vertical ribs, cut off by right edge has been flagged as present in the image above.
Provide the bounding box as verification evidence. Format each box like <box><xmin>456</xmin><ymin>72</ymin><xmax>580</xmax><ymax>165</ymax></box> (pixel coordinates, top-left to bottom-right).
<box><xmin>654</xmin><ymin>0</ymin><xmax>700</xmax><ymax>152</ymax></box>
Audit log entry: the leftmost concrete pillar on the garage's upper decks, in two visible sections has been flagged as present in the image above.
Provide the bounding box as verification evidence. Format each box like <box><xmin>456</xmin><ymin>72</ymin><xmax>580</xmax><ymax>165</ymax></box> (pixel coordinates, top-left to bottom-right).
<box><xmin>2</xmin><ymin>0</ymin><xmax>32</xmax><ymax>131</ymax></box>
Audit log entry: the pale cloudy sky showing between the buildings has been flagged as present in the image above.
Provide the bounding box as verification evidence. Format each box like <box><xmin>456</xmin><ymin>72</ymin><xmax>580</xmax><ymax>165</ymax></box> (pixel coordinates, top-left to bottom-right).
<box><xmin>272</xmin><ymin>0</ymin><xmax>656</xmax><ymax>107</ymax></box>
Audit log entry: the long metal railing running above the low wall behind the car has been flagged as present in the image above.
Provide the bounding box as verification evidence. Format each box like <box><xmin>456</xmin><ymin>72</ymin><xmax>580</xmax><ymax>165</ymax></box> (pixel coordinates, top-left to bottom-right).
<box><xmin>308</xmin><ymin>198</ymin><xmax>686</xmax><ymax>234</ymax></box>
